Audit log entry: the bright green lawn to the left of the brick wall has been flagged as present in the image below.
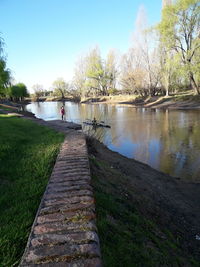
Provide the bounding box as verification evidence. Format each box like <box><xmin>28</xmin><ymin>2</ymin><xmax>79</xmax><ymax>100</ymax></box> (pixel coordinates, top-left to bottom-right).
<box><xmin>0</xmin><ymin>115</ymin><xmax>64</xmax><ymax>266</ymax></box>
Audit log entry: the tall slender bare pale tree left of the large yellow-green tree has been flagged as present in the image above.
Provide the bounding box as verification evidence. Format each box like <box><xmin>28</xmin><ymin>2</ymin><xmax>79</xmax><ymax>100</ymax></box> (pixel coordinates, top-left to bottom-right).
<box><xmin>125</xmin><ymin>5</ymin><xmax>160</xmax><ymax>95</ymax></box>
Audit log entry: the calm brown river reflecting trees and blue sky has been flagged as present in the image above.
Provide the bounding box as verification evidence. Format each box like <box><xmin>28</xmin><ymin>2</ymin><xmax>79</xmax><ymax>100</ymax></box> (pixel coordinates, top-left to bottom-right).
<box><xmin>26</xmin><ymin>102</ymin><xmax>200</xmax><ymax>182</ymax></box>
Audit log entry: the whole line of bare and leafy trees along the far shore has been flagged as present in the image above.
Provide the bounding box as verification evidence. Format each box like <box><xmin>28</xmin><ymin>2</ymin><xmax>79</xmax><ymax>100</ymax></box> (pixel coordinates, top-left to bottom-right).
<box><xmin>0</xmin><ymin>0</ymin><xmax>200</xmax><ymax>100</ymax></box>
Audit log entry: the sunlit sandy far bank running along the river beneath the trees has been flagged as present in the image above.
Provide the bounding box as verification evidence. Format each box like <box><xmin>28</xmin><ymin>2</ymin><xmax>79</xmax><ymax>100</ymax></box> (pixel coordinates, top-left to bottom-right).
<box><xmin>0</xmin><ymin>93</ymin><xmax>200</xmax><ymax>110</ymax></box>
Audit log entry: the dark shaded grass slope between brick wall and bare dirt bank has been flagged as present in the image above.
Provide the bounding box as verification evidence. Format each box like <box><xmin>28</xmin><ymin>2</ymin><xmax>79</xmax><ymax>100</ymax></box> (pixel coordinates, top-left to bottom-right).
<box><xmin>90</xmin><ymin>158</ymin><xmax>199</xmax><ymax>267</ymax></box>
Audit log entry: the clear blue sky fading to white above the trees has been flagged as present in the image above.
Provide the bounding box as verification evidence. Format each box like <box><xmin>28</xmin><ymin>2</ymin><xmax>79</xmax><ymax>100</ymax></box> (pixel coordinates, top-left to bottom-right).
<box><xmin>0</xmin><ymin>0</ymin><xmax>162</xmax><ymax>90</ymax></box>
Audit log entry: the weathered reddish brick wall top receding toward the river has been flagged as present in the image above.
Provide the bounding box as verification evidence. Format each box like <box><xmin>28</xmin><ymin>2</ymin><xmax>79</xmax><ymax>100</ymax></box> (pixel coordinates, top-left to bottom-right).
<box><xmin>20</xmin><ymin>131</ymin><xmax>101</xmax><ymax>267</ymax></box>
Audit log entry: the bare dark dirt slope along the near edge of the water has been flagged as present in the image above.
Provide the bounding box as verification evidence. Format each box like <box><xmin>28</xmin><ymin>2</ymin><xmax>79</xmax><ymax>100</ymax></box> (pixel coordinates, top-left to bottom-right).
<box><xmin>88</xmin><ymin>142</ymin><xmax>200</xmax><ymax>260</ymax></box>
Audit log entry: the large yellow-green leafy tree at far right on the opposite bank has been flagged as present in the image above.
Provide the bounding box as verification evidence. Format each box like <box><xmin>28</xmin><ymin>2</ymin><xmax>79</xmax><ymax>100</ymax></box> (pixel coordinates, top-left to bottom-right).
<box><xmin>158</xmin><ymin>0</ymin><xmax>200</xmax><ymax>94</ymax></box>
